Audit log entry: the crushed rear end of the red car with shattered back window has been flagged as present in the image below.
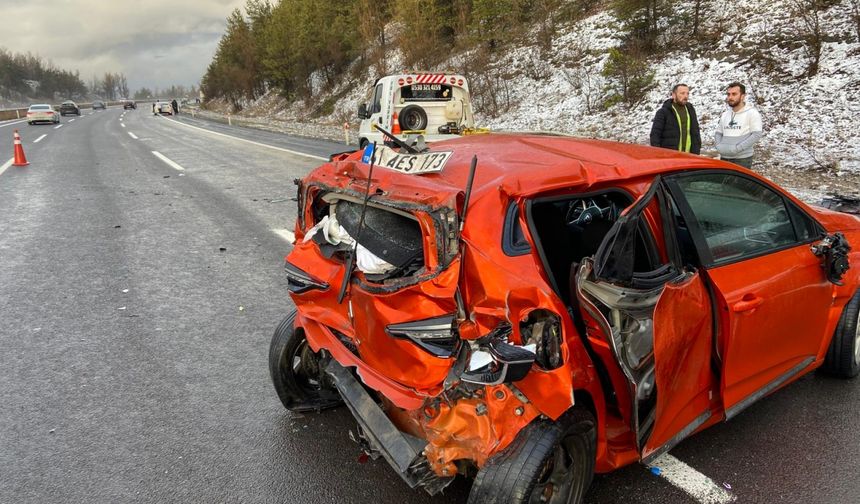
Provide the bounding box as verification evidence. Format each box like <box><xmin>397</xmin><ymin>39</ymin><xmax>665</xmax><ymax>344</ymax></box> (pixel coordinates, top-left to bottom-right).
<box><xmin>270</xmin><ymin>139</ymin><xmax>599</xmax><ymax>493</ymax></box>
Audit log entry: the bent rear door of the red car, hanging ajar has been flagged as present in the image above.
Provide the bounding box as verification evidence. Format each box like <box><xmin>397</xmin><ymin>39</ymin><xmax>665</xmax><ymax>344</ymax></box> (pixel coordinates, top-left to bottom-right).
<box><xmin>576</xmin><ymin>177</ymin><xmax>718</xmax><ymax>463</ymax></box>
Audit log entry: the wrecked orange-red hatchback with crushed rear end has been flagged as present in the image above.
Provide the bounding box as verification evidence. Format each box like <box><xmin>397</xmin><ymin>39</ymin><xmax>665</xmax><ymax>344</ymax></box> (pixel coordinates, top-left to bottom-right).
<box><xmin>270</xmin><ymin>134</ymin><xmax>860</xmax><ymax>503</ymax></box>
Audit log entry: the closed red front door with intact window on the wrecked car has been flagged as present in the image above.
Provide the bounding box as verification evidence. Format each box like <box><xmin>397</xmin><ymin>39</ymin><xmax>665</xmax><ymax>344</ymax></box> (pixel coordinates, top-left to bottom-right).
<box><xmin>669</xmin><ymin>170</ymin><xmax>833</xmax><ymax>419</ymax></box>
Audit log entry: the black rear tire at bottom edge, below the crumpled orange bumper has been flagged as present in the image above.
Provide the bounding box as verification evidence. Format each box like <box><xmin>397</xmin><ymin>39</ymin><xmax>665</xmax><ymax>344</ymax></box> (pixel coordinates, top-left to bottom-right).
<box><xmin>468</xmin><ymin>408</ymin><xmax>597</xmax><ymax>504</ymax></box>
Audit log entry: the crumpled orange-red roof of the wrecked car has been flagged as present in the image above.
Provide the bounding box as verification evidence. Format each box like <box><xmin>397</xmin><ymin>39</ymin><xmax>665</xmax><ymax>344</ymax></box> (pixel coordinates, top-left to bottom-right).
<box><xmin>330</xmin><ymin>133</ymin><xmax>748</xmax><ymax>209</ymax></box>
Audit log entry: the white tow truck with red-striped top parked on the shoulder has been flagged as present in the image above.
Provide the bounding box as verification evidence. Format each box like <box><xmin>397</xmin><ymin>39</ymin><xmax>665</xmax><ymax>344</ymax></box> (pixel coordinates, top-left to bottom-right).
<box><xmin>358</xmin><ymin>72</ymin><xmax>475</xmax><ymax>148</ymax></box>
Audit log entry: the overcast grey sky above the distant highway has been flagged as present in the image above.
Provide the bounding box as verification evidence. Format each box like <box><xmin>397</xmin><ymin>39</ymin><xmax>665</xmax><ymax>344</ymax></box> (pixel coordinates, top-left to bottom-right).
<box><xmin>0</xmin><ymin>0</ymin><xmax>245</xmax><ymax>91</ymax></box>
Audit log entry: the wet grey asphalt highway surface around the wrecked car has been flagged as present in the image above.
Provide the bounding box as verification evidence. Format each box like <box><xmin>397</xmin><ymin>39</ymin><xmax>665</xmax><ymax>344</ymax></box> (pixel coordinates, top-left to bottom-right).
<box><xmin>0</xmin><ymin>107</ymin><xmax>860</xmax><ymax>504</ymax></box>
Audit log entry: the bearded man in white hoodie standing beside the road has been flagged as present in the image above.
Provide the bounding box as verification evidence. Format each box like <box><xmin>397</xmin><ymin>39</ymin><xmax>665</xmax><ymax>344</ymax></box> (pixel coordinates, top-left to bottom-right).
<box><xmin>715</xmin><ymin>82</ymin><xmax>762</xmax><ymax>168</ymax></box>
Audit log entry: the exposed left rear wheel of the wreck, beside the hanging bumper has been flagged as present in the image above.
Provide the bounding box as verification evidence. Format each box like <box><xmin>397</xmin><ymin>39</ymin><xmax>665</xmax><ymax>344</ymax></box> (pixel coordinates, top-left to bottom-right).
<box><xmin>269</xmin><ymin>310</ymin><xmax>343</xmax><ymax>412</ymax></box>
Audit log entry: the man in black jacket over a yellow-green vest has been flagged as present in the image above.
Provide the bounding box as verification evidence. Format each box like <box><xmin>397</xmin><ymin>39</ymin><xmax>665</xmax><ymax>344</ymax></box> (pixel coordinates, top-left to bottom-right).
<box><xmin>651</xmin><ymin>84</ymin><xmax>702</xmax><ymax>154</ymax></box>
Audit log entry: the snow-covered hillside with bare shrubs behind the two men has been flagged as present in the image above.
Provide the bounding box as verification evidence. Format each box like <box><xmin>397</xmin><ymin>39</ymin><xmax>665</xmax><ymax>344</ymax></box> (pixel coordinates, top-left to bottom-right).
<box><xmin>210</xmin><ymin>0</ymin><xmax>860</xmax><ymax>199</ymax></box>
